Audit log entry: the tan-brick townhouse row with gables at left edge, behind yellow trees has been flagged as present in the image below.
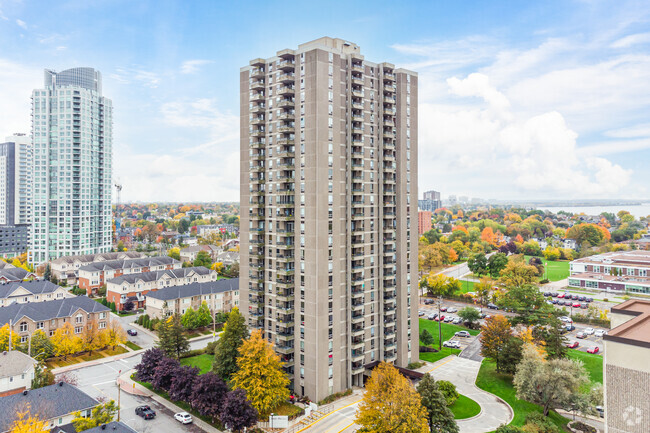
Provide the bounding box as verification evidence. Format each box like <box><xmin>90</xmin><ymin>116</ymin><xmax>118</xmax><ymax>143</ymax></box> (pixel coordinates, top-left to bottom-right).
<box><xmin>0</xmin><ymin>296</ymin><xmax>110</xmax><ymax>343</ymax></box>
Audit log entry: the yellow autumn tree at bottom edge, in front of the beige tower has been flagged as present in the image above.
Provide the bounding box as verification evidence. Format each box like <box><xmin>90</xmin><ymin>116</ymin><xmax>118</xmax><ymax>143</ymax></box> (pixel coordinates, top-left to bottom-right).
<box><xmin>355</xmin><ymin>362</ymin><xmax>429</xmax><ymax>433</ymax></box>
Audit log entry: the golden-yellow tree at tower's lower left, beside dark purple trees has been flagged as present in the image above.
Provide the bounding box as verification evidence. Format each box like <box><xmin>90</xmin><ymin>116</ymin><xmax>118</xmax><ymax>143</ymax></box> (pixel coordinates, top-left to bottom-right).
<box><xmin>232</xmin><ymin>329</ymin><xmax>289</xmax><ymax>417</ymax></box>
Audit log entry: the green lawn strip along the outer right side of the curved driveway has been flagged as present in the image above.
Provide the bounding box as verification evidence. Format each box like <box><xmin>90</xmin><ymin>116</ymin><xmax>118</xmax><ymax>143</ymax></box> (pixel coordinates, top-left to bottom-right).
<box><xmin>476</xmin><ymin>359</ymin><xmax>569</xmax><ymax>431</ymax></box>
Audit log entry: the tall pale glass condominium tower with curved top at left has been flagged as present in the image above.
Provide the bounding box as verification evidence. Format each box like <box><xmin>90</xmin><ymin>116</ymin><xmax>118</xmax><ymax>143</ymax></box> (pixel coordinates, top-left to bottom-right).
<box><xmin>29</xmin><ymin>68</ymin><xmax>113</xmax><ymax>263</ymax></box>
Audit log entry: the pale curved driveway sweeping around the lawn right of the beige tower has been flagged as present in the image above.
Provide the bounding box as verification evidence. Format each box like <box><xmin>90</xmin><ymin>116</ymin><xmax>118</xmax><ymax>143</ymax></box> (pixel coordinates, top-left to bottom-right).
<box><xmin>418</xmin><ymin>356</ymin><xmax>513</xmax><ymax>433</ymax></box>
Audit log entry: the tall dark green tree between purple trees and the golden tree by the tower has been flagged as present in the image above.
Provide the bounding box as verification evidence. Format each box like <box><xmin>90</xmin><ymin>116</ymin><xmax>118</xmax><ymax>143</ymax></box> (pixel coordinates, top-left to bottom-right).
<box><xmin>212</xmin><ymin>308</ymin><xmax>248</xmax><ymax>381</ymax></box>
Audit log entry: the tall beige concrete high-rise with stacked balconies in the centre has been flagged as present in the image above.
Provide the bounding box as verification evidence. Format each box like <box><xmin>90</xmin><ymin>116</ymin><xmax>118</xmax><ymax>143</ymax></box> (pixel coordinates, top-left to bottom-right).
<box><xmin>240</xmin><ymin>37</ymin><xmax>418</xmax><ymax>401</ymax></box>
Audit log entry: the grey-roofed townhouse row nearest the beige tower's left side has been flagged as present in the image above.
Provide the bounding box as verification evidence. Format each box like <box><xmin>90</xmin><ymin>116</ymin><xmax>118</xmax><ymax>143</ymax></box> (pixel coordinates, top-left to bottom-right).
<box><xmin>145</xmin><ymin>278</ymin><xmax>239</xmax><ymax>318</ymax></box>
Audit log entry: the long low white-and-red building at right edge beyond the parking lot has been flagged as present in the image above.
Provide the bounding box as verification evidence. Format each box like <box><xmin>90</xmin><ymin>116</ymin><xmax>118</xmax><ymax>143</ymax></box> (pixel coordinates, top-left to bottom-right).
<box><xmin>569</xmin><ymin>250</ymin><xmax>650</xmax><ymax>294</ymax></box>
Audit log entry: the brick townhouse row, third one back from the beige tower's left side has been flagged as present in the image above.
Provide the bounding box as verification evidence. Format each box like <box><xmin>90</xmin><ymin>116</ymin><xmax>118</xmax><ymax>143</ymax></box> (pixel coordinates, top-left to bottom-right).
<box><xmin>78</xmin><ymin>256</ymin><xmax>182</xmax><ymax>296</ymax></box>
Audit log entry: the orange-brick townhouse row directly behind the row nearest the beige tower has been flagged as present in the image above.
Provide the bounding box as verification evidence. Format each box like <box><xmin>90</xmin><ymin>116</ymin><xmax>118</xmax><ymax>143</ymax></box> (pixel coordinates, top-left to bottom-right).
<box><xmin>106</xmin><ymin>266</ymin><xmax>217</xmax><ymax>310</ymax></box>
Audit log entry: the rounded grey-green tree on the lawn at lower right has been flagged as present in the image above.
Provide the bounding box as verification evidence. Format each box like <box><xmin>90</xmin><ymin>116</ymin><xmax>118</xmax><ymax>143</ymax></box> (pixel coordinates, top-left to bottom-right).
<box><xmin>513</xmin><ymin>344</ymin><xmax>590</xmax><ymax>416</ymax></box>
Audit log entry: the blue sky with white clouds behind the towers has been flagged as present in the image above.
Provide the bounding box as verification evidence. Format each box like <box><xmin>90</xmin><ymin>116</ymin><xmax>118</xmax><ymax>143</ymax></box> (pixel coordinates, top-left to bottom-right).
<box><xmin>0</xmin><ymin>0</ymin><xmax>650</xmax><ymax>202</ymax></box>
